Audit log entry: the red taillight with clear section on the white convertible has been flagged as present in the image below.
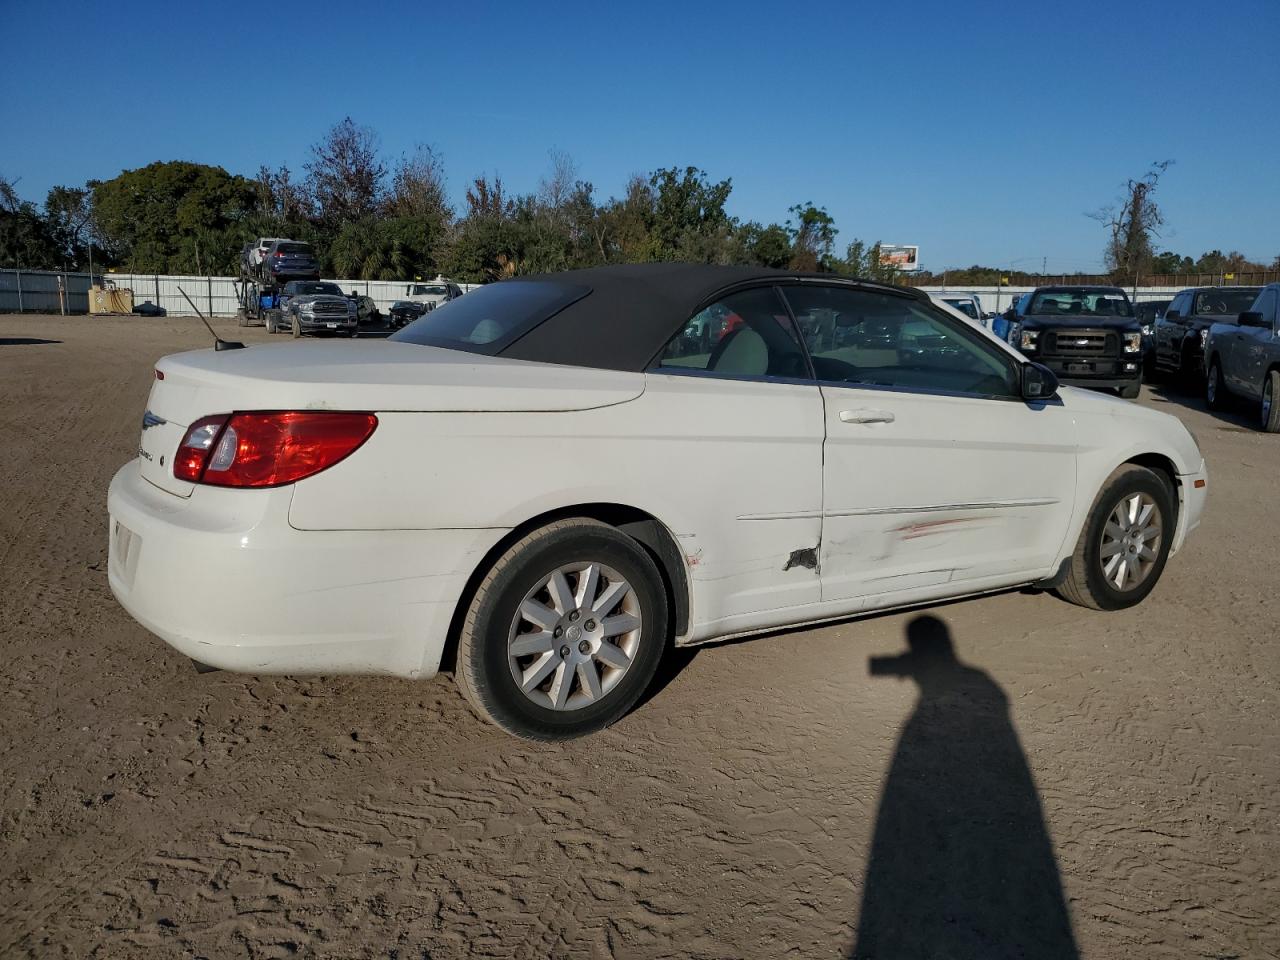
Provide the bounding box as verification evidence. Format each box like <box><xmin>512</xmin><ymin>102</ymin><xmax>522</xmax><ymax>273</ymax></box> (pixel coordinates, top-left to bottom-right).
<box><xmin>173</xmin><ymin>411</ymin><xmax>378</xmax><ymax>486</ymax></box>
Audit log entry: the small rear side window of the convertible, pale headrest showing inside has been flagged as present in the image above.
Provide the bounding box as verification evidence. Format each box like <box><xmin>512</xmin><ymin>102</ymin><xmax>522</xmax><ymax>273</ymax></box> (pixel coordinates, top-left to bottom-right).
<box><xmin>653</xmin><ymin>287</ymin><xmax>809</xmax><ymax>379</ymax></box>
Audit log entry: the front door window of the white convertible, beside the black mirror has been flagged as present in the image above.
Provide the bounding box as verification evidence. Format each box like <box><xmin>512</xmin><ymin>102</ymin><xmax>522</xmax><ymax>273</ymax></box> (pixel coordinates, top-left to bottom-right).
<box><xmin>783</xmin><ymin>285</ymin><xmax>1021</xmax><ymax>397</ymax></box>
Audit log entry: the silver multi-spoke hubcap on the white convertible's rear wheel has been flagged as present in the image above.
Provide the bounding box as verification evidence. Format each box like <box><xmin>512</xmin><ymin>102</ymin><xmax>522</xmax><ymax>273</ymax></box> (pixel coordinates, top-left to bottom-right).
<box><xmin>507</xmin><ymin>562</ymin><xmax>643</xmax><ymax>710</ymax></box>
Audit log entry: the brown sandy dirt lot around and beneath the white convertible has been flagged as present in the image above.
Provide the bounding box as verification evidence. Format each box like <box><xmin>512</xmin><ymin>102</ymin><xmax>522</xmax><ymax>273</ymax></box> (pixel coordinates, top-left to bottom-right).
<box><xmin>0</xmin><ymin>316</ymin><xmax>1280</xmax><ymax>959</ymax></box>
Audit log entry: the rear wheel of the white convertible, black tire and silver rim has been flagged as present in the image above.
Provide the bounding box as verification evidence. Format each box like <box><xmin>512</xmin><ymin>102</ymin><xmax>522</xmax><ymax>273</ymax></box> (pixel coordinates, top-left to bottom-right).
<box><xmin>456</xmin><ymin>520</ymin><xmax>668</xmax><ymax>740</ymax></box>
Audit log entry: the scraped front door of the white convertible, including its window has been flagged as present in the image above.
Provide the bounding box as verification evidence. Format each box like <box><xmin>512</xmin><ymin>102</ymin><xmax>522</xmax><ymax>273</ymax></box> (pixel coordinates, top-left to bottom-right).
<box><xmin>786</xmin><ymin>284</ymin><xmax>1076</xmax><ymax>605</ymax></box>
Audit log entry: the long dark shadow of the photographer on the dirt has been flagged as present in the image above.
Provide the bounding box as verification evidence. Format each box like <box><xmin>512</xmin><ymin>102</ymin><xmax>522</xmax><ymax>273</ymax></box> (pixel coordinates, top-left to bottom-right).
<box><xmin>849</xmin><ymin>616</ymin><xmax>1079</xmax><ymax>960</ymax></box>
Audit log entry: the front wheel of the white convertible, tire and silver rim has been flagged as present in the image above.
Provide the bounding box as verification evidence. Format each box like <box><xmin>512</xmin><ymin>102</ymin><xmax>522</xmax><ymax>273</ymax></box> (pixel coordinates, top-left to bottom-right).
<box><xmin>1055</xmin><ymin>463</ymin><xmax>1175</xmax><ymax>611</ymax></box>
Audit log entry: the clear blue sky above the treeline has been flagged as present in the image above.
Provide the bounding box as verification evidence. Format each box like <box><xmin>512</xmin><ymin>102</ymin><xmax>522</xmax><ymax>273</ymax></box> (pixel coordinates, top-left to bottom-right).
<box><xmin>0</xmin><ymin>0</ymin><xmax>1280</xmax><ymax>270</ymax></box>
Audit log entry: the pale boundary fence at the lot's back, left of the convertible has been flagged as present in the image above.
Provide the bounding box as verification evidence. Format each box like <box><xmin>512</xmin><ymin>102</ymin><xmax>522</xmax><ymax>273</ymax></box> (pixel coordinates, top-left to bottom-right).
<box><xmin>0</xmin><ymin>269</ymin><xmax>479</xmax><ymax>316</ymax></box>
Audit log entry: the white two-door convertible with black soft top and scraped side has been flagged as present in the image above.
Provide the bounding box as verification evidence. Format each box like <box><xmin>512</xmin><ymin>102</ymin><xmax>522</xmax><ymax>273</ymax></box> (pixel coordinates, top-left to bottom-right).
<box><xmin>108</xmin><ymin>264</ymin><xmax>1206</xmax><ymax>740</ymax></box>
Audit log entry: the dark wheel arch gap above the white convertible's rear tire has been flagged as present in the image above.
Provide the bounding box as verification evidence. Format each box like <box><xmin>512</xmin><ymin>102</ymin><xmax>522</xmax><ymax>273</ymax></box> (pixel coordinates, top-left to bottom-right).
<box><xmin>440</xmin><ymin>503</ymin><xmax>690</xmax><ymax>671</ymax></box>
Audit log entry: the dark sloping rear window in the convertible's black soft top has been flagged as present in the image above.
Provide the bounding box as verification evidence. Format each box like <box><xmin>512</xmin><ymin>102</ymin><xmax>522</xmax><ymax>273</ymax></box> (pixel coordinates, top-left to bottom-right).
<box><xmin>390</xmin><ymin>280</ymin><xmax>591</xmax><ymax>356</ymax></box>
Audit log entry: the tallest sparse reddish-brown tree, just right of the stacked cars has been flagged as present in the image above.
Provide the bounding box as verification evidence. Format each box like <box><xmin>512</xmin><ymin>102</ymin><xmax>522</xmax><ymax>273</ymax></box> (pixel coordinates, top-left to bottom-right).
<box><xmin>306</xmin><ymin>116</ymin><xmax>387</xmax><ymax>228</ymax></box>
